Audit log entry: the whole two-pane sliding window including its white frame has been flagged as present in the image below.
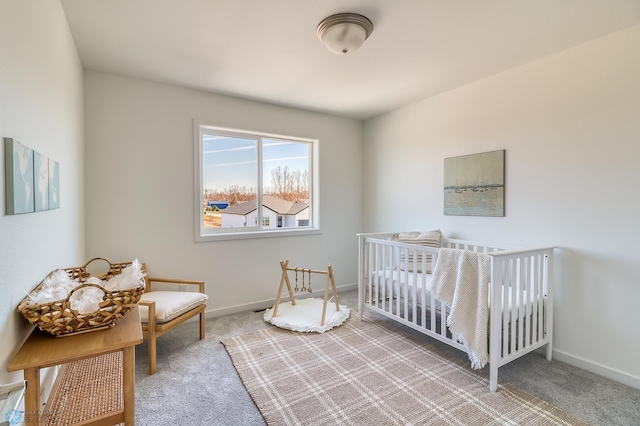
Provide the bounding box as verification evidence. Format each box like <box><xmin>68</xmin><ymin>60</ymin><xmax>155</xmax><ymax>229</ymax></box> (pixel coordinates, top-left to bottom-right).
<box><xmin>194</xmin><ymin>124</ymin><xmax>319</xmax><ymax>241</ymax></box>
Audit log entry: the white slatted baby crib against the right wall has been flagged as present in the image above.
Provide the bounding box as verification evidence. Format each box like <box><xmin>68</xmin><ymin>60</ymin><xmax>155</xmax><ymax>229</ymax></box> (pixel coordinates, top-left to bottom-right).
<box><xmin>358</xmin><ymin>233</ymin><xmax>554</xmax><ymax>392</ymax></box>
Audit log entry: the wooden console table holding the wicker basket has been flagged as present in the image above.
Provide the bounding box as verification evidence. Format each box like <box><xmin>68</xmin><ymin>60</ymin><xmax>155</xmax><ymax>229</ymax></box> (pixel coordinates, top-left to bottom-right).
<box><xmin>7</xmin><ymin>308</ymin><xmax>142</xmax><ymax>426</ymax></box>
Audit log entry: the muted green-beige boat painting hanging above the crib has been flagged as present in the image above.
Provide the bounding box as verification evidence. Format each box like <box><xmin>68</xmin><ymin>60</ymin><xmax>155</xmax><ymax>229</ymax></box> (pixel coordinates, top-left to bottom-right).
<box><xmin>444</xmin><ymin>149</ymin><xmax>505</xmax><ymax>217</ymax></box>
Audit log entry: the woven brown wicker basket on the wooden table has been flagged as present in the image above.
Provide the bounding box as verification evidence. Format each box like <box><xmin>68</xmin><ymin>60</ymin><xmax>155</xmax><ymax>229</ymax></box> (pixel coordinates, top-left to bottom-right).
<box><xmin>18</xmin><ymin>257</ymin><xmax>144</xmax><ymax>337</ymax></box>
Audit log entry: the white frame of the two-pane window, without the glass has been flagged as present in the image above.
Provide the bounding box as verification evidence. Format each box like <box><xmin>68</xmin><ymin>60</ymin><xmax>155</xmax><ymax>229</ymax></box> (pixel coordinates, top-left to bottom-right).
<box><xmin>193</xmin><ymin>120</ymin><xmax>321</xmax><ymax>242</ymax></box>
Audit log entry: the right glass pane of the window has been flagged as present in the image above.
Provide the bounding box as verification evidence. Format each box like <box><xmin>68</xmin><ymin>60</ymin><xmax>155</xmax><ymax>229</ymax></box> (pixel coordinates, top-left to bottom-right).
<box><xmin>262</xmin><ymin>138</ymin><xmax>311</xmax><ymax>228</ymax></box>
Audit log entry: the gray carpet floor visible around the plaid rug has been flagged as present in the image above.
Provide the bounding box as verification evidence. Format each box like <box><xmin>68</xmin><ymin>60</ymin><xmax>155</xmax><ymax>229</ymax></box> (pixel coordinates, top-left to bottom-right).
<box><xmin>131</xmin><ymin>291</ymin><xmax>640</xmax><ymax>426</ymax></box>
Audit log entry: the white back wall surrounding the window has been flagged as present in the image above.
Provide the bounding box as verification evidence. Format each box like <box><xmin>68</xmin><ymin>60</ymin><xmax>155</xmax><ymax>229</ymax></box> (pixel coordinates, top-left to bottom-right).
<box><xmin>85</xmin><ymin>72</ymin><xmax>362</xmax><ymax>314</ymax></box>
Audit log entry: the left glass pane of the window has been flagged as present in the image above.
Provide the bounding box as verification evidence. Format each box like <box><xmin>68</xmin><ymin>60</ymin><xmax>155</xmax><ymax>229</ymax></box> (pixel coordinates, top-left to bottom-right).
<box><xmin>202</xmin><ymin>134</ymin><xmax>258</xmax><ymax>229</ymax></box>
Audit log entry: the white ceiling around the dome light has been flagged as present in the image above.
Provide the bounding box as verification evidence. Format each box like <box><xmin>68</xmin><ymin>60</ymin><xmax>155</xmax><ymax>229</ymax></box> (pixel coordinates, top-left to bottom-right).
<box><xmin>61</xmin><ymin>0</ymin><xmax>640</xmax><ymax>119</ymax></box>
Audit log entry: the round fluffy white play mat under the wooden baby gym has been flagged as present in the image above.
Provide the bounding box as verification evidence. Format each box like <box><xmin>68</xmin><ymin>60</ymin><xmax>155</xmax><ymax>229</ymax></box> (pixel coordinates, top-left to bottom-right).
<box><xmin>264</xmin><ymin>297</ymin><xmax>349</xmax><ymax>333</ymax></box>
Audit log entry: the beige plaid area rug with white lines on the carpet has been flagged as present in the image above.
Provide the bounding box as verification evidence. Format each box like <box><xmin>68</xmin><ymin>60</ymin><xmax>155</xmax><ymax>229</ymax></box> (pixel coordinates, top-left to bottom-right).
<box><xmin>222</xmin><ymin>313</ymin><xmax>585</xmax><ymax>426</ymax></box>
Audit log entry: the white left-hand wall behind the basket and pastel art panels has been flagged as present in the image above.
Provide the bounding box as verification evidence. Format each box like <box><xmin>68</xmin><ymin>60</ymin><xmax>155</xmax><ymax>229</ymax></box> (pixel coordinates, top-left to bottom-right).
<box><xmin>0</xmin><ymin>0</ymin><xmax>85</xmax><ymax>383</ymax></box>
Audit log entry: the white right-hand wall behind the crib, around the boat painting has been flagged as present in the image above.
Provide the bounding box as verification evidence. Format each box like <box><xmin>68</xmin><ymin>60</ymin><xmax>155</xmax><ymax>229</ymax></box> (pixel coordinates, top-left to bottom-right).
<box><xmin>363</xmin><ymin>26</ymin><xmax>640</xmax><ymax>387</ymax></box>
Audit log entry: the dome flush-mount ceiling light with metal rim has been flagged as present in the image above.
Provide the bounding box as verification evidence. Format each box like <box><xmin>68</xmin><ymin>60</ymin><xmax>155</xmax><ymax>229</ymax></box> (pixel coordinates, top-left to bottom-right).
<box><xmin>317</xmin><ymin>13</ymin><xmax>373</xmax><ymax>55</ymax></box>
